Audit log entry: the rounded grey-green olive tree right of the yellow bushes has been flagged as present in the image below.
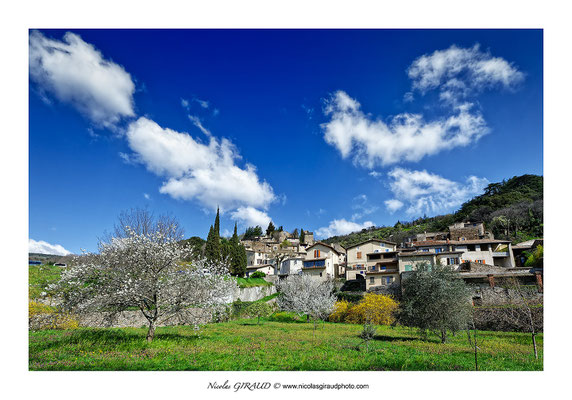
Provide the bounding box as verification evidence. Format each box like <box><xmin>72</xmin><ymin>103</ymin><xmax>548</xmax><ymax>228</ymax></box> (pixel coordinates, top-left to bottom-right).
<box><xmin>399</xmin><ymin>263</ymin><xmax>472</xmax><ymax>343</ymax></box>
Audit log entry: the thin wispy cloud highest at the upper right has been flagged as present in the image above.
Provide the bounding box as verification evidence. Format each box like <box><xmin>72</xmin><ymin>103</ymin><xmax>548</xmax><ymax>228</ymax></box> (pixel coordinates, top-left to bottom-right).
<box><xmin>407</xmin><ymin>44</ymin><xmax>524</xmax><ymax>103</ymax></box>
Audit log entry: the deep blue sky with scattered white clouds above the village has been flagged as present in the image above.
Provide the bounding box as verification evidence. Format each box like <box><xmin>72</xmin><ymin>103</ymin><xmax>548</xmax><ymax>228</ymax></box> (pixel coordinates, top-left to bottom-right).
<box><xmin>29</xmin><ymin>30</ymin><xmax>543</xmax><ymax>253</ymax></box>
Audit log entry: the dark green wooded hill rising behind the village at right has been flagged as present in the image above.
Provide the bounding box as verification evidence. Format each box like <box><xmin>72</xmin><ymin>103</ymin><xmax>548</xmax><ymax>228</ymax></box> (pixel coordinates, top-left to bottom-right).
<box><xmin>323</xmin><ymin>175</ymin><xmax>544</xmax><ymax>247</ymax></box>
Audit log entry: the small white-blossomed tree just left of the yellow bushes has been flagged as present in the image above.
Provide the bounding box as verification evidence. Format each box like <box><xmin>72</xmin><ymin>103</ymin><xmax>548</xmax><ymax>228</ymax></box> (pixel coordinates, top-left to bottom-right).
<box><xmin>276</xmin><ymin>275</ymin><xmax>336</xmax><ymax>329</ymax></box>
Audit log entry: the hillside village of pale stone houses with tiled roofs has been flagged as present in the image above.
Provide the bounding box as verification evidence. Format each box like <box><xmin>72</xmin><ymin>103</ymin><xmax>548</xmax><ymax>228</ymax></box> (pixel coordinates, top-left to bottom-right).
<box><xmin>241</xmin><ymin>222</ymin><xmax>543</xmax><ymax>291</ymax></box>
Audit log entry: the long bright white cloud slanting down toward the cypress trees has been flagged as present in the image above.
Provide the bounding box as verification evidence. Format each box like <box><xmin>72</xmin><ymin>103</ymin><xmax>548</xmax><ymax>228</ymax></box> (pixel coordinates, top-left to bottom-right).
<box><xmin>126</xmin><ymin>117</ymin><xmax>276</xmax><ymax>210</ymax></box>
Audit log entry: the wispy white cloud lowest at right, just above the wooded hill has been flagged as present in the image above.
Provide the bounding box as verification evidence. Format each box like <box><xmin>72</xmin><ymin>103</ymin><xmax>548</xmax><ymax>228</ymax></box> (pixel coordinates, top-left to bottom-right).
<box><xmin>385</xmin><ymin>168</ymin><xmax>489</xmax><ymax>219</ymax></box>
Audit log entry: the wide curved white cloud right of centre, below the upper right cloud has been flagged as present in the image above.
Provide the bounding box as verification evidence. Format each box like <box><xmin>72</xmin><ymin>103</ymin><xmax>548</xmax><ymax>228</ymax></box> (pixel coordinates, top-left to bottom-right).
<box><xmin>321</xmin><ymin>91</ymin><xmax>488</xmax><ymax>168</ymax></box>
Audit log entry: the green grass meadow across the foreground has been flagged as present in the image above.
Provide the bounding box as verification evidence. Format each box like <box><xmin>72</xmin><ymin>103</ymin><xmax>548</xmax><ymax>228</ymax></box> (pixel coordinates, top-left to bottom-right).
<box><xmin>29</xmin><ymin>319</ymin><xmax>543</xmax><ymax>371</ymax></box>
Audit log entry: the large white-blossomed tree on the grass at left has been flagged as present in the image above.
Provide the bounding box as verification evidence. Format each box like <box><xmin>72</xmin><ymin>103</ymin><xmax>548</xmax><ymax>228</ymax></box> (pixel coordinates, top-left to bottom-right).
<box><xmin>50</xmin><ymin>226</ymin><xmax>236</xmax><ymax>342</ymax></box>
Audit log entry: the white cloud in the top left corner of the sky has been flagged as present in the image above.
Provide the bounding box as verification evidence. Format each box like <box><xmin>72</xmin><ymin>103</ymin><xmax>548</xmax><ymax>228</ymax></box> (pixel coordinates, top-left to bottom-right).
<box><xmin>30</xmin><ymin>31</ymin><xmax>135</xmax><ymax>128</ymax></box>
